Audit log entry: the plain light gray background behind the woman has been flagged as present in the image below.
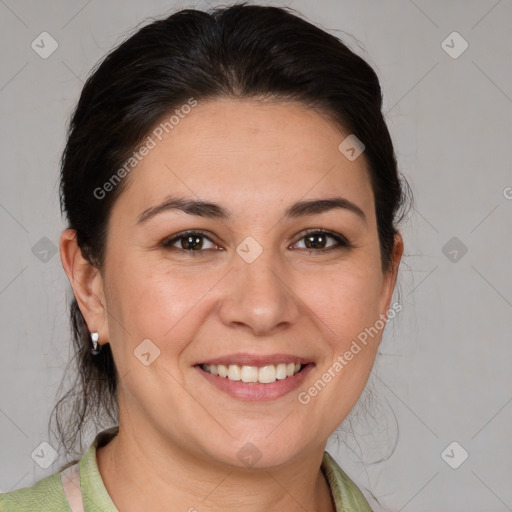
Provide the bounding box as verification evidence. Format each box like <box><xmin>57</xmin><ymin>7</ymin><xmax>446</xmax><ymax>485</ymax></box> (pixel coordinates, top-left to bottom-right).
<box><xmin>0</xmin><ymin>0</ymin><xmax>512</xmax><ymax>512</ymax></box>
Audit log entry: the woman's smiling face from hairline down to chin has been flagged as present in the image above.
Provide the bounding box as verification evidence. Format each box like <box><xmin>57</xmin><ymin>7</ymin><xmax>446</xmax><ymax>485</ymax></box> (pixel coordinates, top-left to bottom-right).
<box><xmin>100</xmin><ymin>99</ymin><xmax>401</xmax><ymax>466</ymax></box>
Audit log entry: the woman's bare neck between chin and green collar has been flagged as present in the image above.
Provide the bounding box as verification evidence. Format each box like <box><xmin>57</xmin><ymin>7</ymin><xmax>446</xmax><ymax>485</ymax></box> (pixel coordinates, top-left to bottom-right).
<box><xmin>96</xmin><ymin>422</ymin><xmax>335</xmax><ymax>512</ymax></box>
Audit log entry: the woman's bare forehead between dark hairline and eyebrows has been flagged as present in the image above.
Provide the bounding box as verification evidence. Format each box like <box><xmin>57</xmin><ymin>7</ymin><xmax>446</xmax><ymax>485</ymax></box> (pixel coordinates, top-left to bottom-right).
<box><xmin>114</xmin><ymin>99</ymin><xmax>373</xmax><ymax>220</ymax></box>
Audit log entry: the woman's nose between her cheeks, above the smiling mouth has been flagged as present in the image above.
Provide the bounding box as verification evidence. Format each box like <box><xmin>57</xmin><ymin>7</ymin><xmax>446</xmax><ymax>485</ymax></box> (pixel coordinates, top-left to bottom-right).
<box><xmin>219</xmin><ymin>250</ymin><xmax>300</xmax><ymax>336</ymax></box>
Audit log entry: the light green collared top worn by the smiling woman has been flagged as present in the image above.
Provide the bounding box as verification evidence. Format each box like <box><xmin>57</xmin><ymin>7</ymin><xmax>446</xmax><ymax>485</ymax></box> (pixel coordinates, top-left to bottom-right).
<box><xmin>0</xmin><ymin>426</ymin><xmax>372</xmax><ymax>512</ymax></box>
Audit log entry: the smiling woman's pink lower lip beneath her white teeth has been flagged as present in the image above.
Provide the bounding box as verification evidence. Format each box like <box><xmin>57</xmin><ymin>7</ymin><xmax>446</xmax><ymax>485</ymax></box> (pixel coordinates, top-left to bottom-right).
<box><xmin>194</xmin><ymin>363</ymin><xmax>314</xmax><ymax>402</ymax></box>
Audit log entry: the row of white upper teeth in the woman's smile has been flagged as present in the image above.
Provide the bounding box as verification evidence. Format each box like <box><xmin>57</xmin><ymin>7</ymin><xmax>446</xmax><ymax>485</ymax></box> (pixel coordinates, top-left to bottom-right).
<box><xmin>201</xmin><ymin>363</ymin><xmax>301</xmax><ymax>384</ymax></box>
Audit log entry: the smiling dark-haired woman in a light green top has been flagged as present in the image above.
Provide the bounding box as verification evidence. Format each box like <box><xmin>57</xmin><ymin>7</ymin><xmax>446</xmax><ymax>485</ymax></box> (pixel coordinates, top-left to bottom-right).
<box><xmin>0</xmin><ymin>5</ymin><xmax>403</xmax><ymax>512</ymax></box>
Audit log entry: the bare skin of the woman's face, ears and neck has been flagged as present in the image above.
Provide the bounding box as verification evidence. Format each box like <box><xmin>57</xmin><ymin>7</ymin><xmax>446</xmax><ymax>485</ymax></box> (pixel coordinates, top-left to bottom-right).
<box><xmin>60</xmin><ymin>99</ymin><xmax>403</xmax><ymax>512</ymax></box>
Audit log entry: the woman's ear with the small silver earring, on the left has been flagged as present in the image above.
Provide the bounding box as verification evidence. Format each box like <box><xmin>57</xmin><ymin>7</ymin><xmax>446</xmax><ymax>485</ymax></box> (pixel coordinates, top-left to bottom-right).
<box><xmin>59</xmin><ymin>229</ymin><xmax>109</xmax><ymax>344</ymax></box>
